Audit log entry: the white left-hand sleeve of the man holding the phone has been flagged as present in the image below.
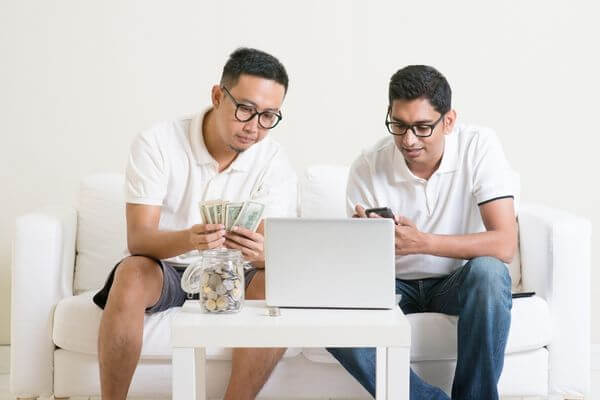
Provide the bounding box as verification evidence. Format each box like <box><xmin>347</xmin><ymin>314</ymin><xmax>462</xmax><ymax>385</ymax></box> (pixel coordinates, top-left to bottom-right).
<box><xmin>346</xmin><ymin>155</ymin><xmax>376</xmax><ymax>217</ymax></box>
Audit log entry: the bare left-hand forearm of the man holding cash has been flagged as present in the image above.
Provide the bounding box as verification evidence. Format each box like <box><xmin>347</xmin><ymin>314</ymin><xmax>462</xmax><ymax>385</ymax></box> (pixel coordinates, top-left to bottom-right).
<box><xmin>127</xmin><ymin>229</ymin><xmax>194</xmax><ymax>260</ymax></box>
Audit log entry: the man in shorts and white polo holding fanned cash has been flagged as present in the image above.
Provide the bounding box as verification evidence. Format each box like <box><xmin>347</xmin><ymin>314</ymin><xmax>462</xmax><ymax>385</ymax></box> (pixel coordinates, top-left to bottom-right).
<box><xmin>94</xmin><ymin>48</ymin><xmax>297</xmax><ymax>400</ymax></box>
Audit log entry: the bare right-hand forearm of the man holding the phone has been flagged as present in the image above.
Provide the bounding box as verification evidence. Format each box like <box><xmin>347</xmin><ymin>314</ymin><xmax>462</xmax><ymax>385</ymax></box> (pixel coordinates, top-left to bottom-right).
<box><xmin>423</xmin><ymin>231</ymin><xmax>517</xmax><ymax>263</ymax></box>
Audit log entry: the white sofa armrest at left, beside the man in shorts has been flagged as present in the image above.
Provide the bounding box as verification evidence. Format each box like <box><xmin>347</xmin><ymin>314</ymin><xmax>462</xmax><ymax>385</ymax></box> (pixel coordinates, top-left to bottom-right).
<box><xmin>10</xmin><ymin>207</ymin><xmax>77</xmax><ymax>397</ymax></box>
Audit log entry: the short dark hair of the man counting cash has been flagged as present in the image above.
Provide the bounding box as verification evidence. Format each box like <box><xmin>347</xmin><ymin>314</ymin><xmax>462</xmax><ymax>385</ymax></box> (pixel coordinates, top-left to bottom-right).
<box><xmin>221</xmin><ymin>47</ymin><xmax>288</xmax><ymax>93</ymax></box>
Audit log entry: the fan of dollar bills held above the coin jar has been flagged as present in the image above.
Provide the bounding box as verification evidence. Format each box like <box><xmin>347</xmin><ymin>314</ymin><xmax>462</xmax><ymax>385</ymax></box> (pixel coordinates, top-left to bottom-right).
<box><xmin>200</xmin><ymin>200</ymin><xmax>265</xmax><ymax>232</ymax></box>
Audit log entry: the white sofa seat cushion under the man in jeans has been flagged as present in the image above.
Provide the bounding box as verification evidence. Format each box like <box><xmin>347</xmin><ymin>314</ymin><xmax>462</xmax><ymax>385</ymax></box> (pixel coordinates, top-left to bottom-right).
<box><xmin>302</xmin><ymin>296</ymin><xmax>552</xmax><ymax>362</ymax></box>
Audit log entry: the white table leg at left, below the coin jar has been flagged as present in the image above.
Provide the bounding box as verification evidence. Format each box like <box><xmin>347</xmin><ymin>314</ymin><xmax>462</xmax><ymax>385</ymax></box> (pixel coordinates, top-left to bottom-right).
<box><xmin>172</xmin><ymin>347</ymin><xmax>206</xmax><ymax>400</ymax></box>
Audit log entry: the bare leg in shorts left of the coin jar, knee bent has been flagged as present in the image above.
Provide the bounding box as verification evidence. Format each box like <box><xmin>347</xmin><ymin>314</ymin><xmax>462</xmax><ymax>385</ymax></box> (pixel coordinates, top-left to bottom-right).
<box><xmin>98</xmin><ymin>257</ymin><xmax>163</xmax><ymax>400</ymax></box>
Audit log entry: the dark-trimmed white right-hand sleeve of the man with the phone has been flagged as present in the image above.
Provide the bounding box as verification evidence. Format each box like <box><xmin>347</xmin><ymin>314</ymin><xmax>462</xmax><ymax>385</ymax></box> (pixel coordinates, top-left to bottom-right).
<box><xmin>473</xmin><ymin>131</ymin><xmax>516</xmax><ymax>205</ymax></box>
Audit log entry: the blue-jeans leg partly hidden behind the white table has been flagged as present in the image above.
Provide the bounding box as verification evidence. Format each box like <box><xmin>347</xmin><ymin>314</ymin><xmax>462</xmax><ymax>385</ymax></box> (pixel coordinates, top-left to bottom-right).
<box><xmin>327</xmin><ymin>280</ymin><xmax>448</xmax><ymax>400</ymax></box>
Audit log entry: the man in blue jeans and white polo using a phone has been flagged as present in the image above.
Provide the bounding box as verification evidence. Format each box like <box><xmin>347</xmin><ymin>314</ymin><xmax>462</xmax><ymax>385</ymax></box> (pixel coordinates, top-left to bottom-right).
<box><xmin>328</xmin><ymin>65</ymin><xmax>517</xmax><ymax>400</ymax></box>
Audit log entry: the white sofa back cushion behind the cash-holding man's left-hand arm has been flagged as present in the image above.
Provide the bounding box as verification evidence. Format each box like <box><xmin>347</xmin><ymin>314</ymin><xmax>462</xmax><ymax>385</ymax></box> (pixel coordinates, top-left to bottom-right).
<box><xmin>73</xmin><ymin>174</ymin><xmax>127</xmax><ymax>293</ymax></box>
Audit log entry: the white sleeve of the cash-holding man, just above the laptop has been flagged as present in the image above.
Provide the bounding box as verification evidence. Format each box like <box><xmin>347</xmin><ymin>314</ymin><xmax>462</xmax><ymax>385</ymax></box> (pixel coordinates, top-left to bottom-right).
<box><xmin>251</xmin><ymin>149</ymin><xmax>298</xmax><ymax>218</ymax></box>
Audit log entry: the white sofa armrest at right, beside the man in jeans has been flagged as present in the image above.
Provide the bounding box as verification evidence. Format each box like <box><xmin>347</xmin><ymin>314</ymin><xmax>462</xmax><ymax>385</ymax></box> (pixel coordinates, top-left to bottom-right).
<box><xmin>519</xmin><ymin>204</ymin><xmax>591</xmax><ymax>396</ymax></box>
